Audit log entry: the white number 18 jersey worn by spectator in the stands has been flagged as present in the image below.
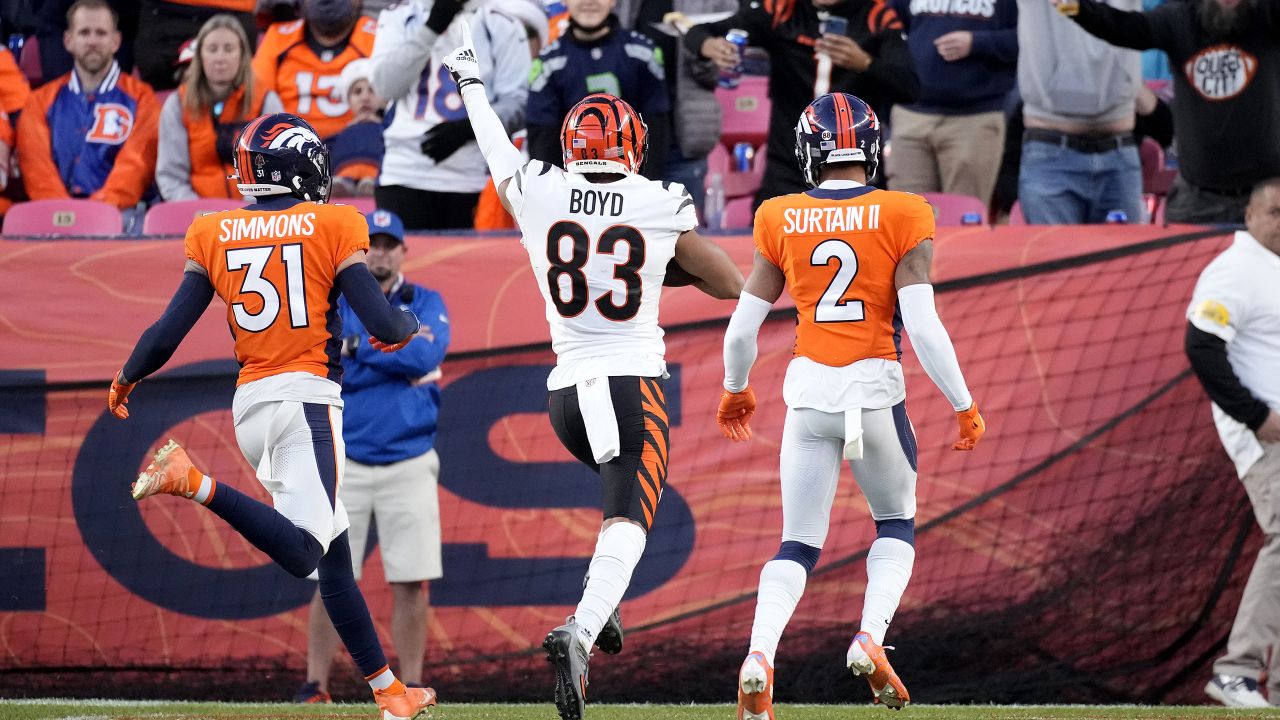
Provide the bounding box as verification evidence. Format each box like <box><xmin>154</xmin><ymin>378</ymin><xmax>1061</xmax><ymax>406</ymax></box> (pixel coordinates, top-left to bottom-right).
<box><xmin>371</xmin><ymin>0</ymin><xmax>531</xmax><ymax>192</ymax></box>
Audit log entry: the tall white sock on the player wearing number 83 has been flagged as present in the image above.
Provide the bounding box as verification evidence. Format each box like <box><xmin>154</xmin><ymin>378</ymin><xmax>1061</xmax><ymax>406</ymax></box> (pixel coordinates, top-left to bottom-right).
<box><xmin>573</xmin><ymin>523</ymin><xmax>646</xmax><ymax>652</ymax></box>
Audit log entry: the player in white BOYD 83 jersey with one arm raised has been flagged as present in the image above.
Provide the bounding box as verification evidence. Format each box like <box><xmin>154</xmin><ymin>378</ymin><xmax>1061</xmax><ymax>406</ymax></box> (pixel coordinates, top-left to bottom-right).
<box><xmin>444</xmin><ymin>25</ymin><xmax>742</xmax><ymax>720</ymax></box>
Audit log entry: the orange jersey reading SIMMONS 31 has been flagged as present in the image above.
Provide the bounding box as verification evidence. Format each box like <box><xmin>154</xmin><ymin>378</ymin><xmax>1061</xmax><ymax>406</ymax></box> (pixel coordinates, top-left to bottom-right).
<box><xmin>186</xmin><ymin>202</ymin><xmax>369</xmax><ymax>384</ymax></box>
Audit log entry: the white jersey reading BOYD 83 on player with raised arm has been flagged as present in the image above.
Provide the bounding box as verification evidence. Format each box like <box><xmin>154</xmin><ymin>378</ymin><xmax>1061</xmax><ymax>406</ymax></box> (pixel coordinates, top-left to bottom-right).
<box><xmin>507</xmin><ymin>160</ymin><xmax>698</xmax><ymax>389</ymax></box>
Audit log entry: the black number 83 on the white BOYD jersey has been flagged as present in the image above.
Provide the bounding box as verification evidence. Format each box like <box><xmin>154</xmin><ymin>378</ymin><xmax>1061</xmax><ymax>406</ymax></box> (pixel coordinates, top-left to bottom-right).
<box><xmin>547</xmin><ymin>220</ymin><xmax>644</xmax><ymax>323</ymax></box>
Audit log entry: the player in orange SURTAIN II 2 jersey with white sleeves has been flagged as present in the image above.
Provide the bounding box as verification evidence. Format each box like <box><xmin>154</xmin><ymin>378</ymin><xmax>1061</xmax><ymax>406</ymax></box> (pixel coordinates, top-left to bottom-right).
<box><xmin>717</xmin><ymin>92</ymin><xmax>984</xmax><ymax>720</ymax></box>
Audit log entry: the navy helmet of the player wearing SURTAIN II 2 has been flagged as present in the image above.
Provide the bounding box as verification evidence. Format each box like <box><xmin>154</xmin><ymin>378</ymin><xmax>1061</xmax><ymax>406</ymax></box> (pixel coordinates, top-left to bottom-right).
<box><xmin>796</xmin><ymin>92</ymin><xmax>879</xmax><ymax>187</ymax></box>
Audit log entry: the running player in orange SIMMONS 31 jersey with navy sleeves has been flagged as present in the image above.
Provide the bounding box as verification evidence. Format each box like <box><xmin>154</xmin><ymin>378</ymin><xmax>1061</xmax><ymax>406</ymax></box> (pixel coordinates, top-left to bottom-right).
<box><xmin>106</xmin><ymin>113</ymin><xmax>435</xmax><ymax>720</ymax></box>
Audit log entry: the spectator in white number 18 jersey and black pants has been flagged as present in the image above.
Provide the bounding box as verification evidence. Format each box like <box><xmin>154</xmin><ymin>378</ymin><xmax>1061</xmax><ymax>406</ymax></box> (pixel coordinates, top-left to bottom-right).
<box><xmin>371</xmin><ymin>0</ymin><xmax>530</xmax><ymax>229</ymax></box>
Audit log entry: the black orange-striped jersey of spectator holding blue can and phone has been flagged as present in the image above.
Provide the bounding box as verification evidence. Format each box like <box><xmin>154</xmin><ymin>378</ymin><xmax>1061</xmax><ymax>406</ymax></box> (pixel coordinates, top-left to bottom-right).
<box><xmin>685</xmin><ymin>0</ymin><xmax>920</xmax><ymax>200</ymax></box>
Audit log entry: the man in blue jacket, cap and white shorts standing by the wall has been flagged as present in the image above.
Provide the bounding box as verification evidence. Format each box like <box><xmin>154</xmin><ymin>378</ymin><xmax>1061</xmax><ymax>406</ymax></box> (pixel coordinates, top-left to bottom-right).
<box><xmin>294</xmin><ymin>210</ymin><xmax>449</xmax><ymax>702</ymax></box>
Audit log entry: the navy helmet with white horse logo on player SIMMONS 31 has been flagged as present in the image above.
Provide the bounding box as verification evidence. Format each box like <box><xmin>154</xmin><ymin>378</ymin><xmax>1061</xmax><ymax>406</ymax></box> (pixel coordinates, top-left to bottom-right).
<box><xmin>233</xmin><ymin>113</ymin><xmax>333</xmax><ymax>202</ymax></box>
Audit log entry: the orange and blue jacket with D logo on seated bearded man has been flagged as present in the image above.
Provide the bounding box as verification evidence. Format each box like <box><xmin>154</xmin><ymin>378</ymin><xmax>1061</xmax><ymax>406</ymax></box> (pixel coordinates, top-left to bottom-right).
<box><xmin>18</xmin><ymin>61</ymin><xmax>160</xmax><ymax>207</ymax></box>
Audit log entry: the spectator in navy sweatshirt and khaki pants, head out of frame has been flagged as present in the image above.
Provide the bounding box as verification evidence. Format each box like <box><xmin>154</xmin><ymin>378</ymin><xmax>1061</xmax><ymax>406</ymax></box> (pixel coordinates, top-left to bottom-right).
<box><xmin>887</xmin><ymin>0</ymin><xmax>1018</xmax><ymax>204</ymax></box>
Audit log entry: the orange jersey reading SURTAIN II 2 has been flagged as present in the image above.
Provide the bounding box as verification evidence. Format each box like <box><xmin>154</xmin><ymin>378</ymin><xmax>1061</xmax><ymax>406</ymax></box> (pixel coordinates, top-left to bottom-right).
<box><xmin>755</xmin><ymin>186</ymin><xmax>933</xmax><ymax>368</ymax></box>
